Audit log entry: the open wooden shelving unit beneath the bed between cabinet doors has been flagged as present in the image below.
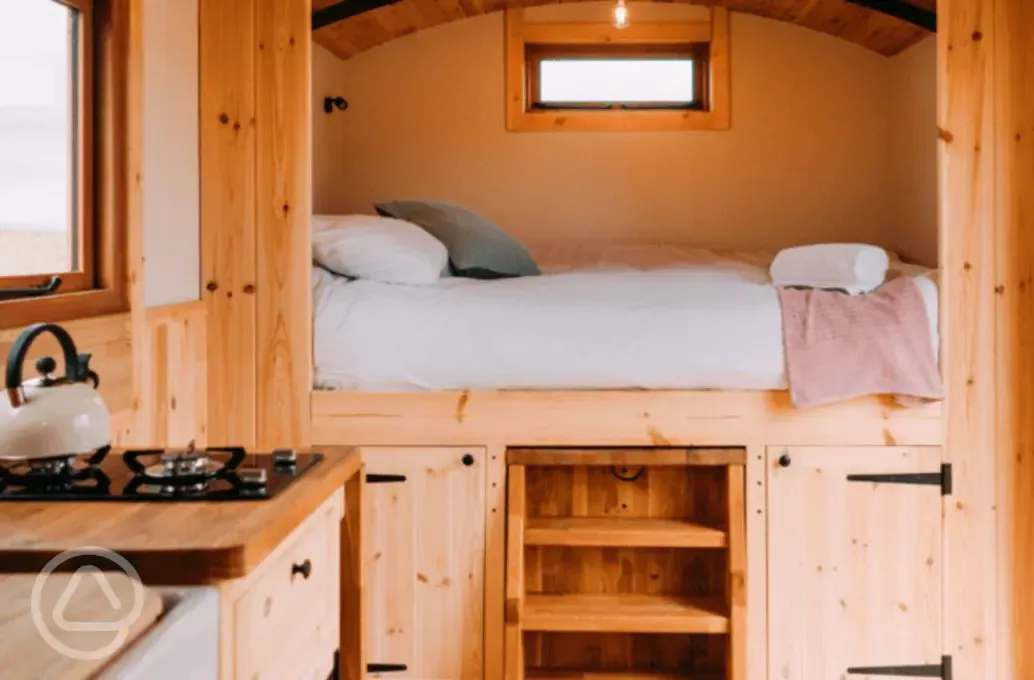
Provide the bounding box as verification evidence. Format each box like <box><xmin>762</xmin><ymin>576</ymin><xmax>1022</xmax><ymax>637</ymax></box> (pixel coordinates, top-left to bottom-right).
<box><xmin>506</xmin><ymin>449</ymin><xmax>747</xmax><ymax>680</ymax></box>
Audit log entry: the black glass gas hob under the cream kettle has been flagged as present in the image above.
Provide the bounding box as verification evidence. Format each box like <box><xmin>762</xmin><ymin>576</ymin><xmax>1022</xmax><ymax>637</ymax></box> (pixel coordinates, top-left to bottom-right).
<box><xmin>0</xmin><ymin>447</ymin><xmax>323</xmax><ymax>502</ymax></box>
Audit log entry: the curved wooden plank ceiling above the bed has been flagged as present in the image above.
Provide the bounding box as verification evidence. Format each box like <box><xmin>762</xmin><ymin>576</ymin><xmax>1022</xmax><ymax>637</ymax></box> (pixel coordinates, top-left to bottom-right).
<box><xmin>312</xmin><ymin>0</ymin><xmax>934</xmax><ymax>59</ymax></box>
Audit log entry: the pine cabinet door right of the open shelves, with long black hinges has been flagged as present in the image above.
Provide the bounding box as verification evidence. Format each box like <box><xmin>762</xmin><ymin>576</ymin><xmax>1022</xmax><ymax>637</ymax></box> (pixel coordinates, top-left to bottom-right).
<box><xmin>768</xmin><ymin>446</ymin><xmax>943</xmax><ymax>680</ymax></box>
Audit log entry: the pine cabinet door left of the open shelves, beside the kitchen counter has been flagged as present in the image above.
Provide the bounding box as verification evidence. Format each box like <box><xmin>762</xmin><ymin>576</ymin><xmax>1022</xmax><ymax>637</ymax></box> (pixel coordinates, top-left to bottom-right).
<box><xmin>363</xmin><ymin>447</ymin><xmax>486</xmax><ymax>680</ymax></box>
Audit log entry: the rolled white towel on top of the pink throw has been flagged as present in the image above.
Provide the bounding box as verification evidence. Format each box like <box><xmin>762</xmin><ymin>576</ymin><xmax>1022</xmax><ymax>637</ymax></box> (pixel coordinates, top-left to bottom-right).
<box><xmin>769</xmin><ymin>243</ymin><xmax>890</xmax><ymax>295</ymax></box>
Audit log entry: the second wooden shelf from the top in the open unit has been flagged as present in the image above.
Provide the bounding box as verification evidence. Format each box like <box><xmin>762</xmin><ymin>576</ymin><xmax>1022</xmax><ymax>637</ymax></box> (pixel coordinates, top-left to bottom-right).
<box><xmin>520</xmin><ymin>594</ymin><xmax>729</xmax><ymax>635</ymax></box>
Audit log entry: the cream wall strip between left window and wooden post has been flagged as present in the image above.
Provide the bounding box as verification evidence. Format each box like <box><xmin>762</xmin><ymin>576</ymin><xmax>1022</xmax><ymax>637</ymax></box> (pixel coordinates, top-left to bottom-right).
<box><xmin>144</xmin><ymin>0</ymin><xmax>201</xmax><ymax>307</ymax></box>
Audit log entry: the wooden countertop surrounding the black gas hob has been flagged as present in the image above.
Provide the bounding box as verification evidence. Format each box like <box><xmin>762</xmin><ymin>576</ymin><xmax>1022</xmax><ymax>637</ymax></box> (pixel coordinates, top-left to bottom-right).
<box><xmin>0</xmin><ymin>447</ymin><xmax>362</xmax><ymax>585</ymax></box>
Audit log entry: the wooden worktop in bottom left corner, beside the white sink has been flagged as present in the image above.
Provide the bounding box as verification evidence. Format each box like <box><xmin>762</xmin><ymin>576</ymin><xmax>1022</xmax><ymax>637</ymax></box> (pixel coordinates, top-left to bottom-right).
<box><xmin>0</xmin><ymin>573</ymin><xmax>162</xmax><ymax>680</ymax></box>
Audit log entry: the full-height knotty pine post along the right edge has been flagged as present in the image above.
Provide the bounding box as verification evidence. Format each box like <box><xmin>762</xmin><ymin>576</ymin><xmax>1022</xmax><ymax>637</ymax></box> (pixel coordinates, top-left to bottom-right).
<box><xmin>938</xmin><ymin>0</ymin><xmax>1034</xmax><ymax>679</ymax></box>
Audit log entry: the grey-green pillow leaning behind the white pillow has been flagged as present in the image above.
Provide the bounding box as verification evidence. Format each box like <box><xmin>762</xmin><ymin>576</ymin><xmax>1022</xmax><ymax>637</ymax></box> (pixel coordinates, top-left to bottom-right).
<box><xmin>373</xmin><ymin>200</ymin><xmax>541</xmax><ymax>279</ymax></box>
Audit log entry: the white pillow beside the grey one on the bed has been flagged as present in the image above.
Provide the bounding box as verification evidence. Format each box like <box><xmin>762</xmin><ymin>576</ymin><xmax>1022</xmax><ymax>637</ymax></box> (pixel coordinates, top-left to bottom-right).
<box><xmin>312</xmin><ymin>215</ymin><xmax>449</xmax><ymax>285</ymax></box>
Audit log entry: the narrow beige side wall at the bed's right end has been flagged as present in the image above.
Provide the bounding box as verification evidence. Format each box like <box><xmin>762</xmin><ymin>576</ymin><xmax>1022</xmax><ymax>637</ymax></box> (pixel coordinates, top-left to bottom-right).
<box><xmin>889</xmin><ymin>36</ymin><xmax>938</xmax><ymax>266</ymax></box>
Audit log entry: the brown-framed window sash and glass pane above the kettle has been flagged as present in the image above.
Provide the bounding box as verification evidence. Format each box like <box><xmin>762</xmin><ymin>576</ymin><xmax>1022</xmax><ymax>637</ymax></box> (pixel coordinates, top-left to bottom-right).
<box><xmin>0</xmin><ymin>0</ymin><xmax>97</xmax><ymax>293</ymax></box>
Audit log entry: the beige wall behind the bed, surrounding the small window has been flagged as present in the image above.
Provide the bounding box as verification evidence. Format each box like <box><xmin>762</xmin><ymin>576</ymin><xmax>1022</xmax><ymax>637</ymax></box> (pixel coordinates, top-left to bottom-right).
<box><xmin>313</xmin><ymin>3</ymin><xmax>933</xmax><ymax>254</ymax></box>
